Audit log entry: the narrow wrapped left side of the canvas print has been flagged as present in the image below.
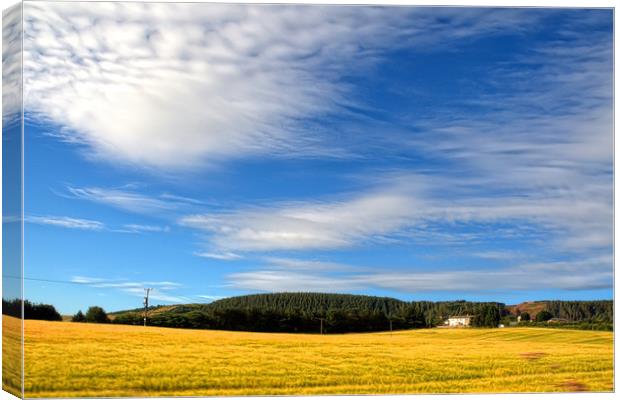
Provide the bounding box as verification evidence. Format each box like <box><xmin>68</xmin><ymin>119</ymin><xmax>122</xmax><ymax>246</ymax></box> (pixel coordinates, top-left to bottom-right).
<box><xmin>2</xmin><ymin>4</ymin><xmax>24</xmax><ymax>397</ymax></box>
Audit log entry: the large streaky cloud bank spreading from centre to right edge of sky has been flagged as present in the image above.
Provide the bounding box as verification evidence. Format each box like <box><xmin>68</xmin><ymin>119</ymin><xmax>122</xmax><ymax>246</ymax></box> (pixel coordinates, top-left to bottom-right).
<box><xmin>180</xmin><ymin>15</ymin><xmax>613</xmax><ymax>260</ymax></box>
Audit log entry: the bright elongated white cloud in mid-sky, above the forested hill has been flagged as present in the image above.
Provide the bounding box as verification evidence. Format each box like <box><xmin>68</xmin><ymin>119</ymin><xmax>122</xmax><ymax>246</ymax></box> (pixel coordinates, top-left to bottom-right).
<box><xmin>179</xmin><ymin>184</ymin><xmax>420</xmax><ymax>251</ymax></box>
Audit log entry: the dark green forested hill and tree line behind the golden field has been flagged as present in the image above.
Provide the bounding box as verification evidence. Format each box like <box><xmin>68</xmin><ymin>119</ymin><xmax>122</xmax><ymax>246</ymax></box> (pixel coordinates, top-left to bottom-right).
<box><xmin>109</xmin><ymin>293</ymin><xmax>613</xmax><ymax>333</ymax></box>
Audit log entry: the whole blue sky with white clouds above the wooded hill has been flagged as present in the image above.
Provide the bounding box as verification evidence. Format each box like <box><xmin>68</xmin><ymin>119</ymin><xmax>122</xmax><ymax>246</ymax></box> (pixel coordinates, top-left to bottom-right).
<box><xmin>12</xmin><ymin>3</ymin><xmax>613</xmax><ymax>313</ymax></box>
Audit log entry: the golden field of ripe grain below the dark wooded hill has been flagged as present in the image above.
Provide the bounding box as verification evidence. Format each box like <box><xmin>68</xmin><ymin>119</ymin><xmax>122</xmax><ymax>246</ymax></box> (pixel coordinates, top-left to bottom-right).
<box><xmin>5</xmin><ymin>317</ymin><xmax>613</xmax><ymax>397</ymax></box>
